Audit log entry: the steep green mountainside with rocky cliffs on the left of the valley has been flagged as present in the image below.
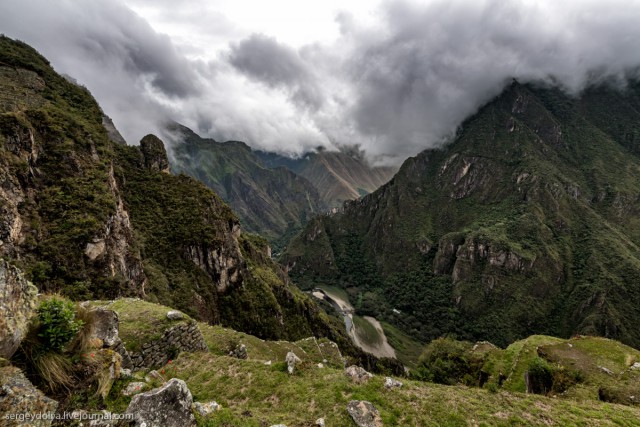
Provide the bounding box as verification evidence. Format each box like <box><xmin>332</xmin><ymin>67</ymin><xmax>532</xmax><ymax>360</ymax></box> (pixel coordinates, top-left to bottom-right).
<box><xmin>0</xmin><ymin>36</ymin><xmax>366</xmax><ymax>352</ymax></box>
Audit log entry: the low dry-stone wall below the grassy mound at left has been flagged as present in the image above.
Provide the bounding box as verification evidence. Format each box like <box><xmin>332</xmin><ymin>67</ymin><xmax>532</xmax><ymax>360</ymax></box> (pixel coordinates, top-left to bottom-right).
<box><xmin>129</xmin><ymin>321</ymin><xmax>209</xmax><ymax>370</ymax></box>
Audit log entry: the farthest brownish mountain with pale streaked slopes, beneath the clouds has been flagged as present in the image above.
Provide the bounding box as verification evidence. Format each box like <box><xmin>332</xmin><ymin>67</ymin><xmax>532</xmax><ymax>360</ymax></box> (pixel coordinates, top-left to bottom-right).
<box><xmin>257</xmin><ymin>146</ymin><xmax>397</xmax><ymax>208</ymax></box>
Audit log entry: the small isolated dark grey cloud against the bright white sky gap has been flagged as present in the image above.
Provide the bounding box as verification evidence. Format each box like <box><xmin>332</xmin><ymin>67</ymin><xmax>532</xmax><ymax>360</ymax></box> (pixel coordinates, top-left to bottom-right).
<box><xmin>229</xmin><ymin>34</ymin><xmax>323</xmax><ymax>110</ymax></box>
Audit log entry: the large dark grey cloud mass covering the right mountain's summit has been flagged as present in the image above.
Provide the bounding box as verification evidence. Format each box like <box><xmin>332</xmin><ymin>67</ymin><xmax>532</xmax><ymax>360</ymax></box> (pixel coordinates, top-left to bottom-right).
<box><xmin>332</xmin><ymin>1</ymin><xmax>640</xmax><ymax>159</ymax></box>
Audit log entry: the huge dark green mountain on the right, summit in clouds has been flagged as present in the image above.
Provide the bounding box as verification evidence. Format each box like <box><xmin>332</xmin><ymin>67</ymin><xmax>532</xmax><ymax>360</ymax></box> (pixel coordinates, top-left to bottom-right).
<box><xmin>283</xmin><ymin>81</ymin><xmax>640</xmax><ymax>347</ymax></box>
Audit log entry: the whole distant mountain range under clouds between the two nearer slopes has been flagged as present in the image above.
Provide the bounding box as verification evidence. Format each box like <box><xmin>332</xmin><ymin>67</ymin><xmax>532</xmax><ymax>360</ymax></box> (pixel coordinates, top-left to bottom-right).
<box><xmin>167</xmin><ymin>123</ymin><xmax>395</xmax><ymax>250</ymax></box>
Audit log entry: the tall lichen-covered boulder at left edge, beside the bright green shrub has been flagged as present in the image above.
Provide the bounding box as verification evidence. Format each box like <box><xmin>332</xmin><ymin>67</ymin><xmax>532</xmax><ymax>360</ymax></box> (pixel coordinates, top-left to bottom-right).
<box><xmin>0</xmin><ymin>259</ymin><xmax>38</xmax><ymax>359</ymax></box>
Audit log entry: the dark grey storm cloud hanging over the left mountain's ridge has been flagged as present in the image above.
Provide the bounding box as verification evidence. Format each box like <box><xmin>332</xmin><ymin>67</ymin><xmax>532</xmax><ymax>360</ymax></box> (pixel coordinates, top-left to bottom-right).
<box><xmin>0</xmin><ymin>0</ymin><xmax>201</xmax><ymax>142</ymax></box>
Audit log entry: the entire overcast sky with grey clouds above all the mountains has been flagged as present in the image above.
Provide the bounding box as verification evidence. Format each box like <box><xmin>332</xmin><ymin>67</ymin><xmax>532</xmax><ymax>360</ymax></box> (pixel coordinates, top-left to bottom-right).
<box><xmin>0</xmin><ymin>0</ymin><xmax>640</xmax><ymax>161</ymax></box>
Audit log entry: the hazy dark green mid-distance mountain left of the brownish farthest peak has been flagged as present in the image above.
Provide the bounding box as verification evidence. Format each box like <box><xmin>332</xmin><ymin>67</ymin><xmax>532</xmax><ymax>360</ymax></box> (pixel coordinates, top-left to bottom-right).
<box><xmin>168</xmin><ymin>123</ymin><xmax>326</xmax><ymax>250</ymax></box>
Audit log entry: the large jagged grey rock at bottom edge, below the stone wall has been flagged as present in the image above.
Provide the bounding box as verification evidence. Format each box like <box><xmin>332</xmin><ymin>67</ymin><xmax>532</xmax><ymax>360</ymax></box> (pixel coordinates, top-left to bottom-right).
<box><xmin>125</xmin><ymin>378</ymin><xmax>196</xmax><ymax>427</ymax></box>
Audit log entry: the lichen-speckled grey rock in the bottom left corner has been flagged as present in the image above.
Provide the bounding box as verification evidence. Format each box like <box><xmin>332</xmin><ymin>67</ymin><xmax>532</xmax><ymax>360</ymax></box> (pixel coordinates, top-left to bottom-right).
<box><xmin>0</xmin><ymin>366</ymin><xmax>58</xmax><ymax>427</ymax></box>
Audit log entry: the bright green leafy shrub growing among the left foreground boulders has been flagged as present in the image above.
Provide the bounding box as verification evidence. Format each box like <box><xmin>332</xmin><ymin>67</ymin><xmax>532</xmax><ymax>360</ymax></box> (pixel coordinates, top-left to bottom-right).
<box><xmin>38</xmin><ymin>298</ymin><xmax>84</xmax><ymax>351</ymax></box>
